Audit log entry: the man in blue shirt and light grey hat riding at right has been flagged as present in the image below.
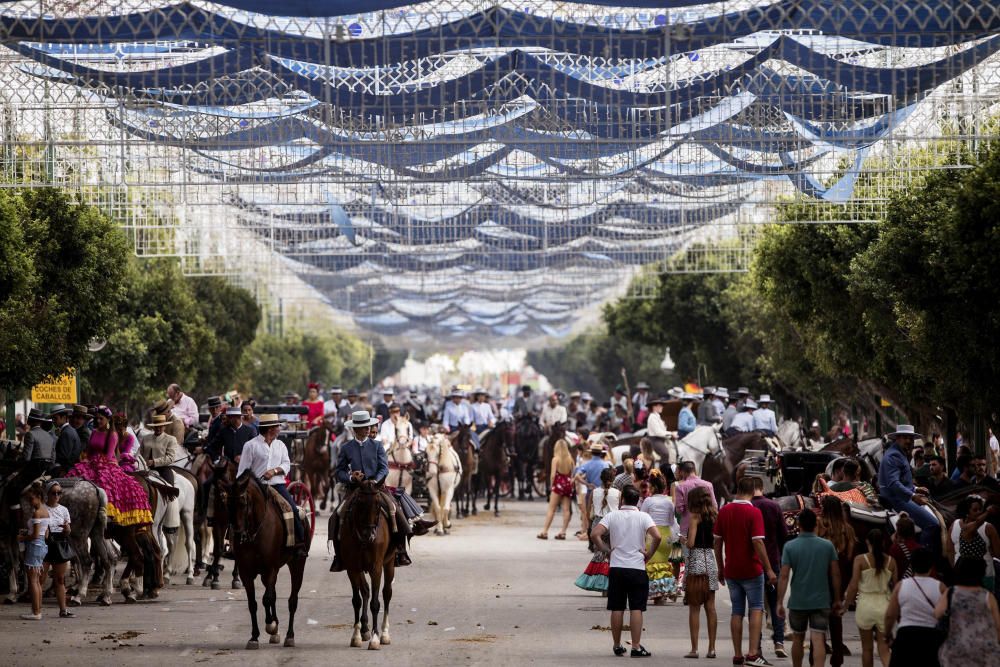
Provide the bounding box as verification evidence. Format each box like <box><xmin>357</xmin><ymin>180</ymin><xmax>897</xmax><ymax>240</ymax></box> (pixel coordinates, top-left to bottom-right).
<box><xmin>878</xmin><ymin>424</ymin><xmax>941</xmax><ymax>555</ymax></box>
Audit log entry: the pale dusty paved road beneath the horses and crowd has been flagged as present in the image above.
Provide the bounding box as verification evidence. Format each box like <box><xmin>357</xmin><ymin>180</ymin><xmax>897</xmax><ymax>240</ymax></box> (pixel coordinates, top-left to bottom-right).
<box><xmin>0</xmin><ymin>502</ymin><xmax>860</xmax><ymax>667</ymax></box>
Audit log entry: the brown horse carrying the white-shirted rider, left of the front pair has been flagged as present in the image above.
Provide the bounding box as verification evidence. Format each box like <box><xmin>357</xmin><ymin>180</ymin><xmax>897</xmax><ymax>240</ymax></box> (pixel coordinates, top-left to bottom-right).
<box><xmin>227</xmin><ymin>470</ymin><xmax>312</xmax><ymax>649</ymax></box>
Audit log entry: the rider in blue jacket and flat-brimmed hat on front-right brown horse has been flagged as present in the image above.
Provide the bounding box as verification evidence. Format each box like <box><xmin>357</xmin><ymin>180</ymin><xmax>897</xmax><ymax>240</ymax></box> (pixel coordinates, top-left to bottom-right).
<box><xmin>330</xmin><ymin>410</ymin><xmax>434</xmax><ymax>572</ymax></box>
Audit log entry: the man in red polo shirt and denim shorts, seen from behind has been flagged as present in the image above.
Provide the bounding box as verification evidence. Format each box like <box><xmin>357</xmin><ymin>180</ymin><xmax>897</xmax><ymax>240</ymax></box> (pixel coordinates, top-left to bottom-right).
<box><xmin>715</xmin><ymin>477</ymin><xmax>778</xmax><ymax>667</ymax></box>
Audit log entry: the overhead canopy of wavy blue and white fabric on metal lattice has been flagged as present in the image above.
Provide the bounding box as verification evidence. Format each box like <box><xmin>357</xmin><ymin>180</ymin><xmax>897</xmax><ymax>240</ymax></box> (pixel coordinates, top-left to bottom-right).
<box><xmin>0</xmin><ymin>0</ymin><xmax>1000</xmax><ymax>340</ymax></box>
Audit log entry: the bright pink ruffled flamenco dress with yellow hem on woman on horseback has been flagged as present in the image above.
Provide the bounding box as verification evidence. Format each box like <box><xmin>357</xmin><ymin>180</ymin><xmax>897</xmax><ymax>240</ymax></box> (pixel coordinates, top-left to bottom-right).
<box><xmin>67</xmin><ymin>431</ymin><xmax>153</xmax><ymax>526</ymax></box>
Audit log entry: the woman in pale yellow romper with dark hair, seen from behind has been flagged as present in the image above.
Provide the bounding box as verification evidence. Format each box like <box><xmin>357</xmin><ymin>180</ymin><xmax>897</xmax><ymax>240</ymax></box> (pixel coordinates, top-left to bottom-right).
<box><xmin>843</xmin><ymin>528</ymin><xmax>896</xmax><ymax>667</ymax></box>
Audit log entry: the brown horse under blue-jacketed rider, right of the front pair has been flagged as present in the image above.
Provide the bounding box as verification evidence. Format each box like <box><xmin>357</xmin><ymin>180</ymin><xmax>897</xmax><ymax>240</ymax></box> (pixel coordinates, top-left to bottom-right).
<box><xmin>330</xmin><ymin>480</ymin><xmax>402</xmax><ymax>650</ymax></box>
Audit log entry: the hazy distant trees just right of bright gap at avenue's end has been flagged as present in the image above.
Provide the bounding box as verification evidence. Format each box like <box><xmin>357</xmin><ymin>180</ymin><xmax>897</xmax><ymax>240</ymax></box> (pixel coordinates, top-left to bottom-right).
<box><xmin>527</xmin><ymin>330</ymin><xmax>678</xmax><ymax>398</ymax></box>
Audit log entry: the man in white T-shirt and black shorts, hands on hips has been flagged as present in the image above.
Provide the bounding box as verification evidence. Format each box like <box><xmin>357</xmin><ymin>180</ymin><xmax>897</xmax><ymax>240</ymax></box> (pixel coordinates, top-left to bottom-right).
<box><xmin>591</xmin><ymin>485</ymin><xmax>660</xmax><ymax>658</ymax></box>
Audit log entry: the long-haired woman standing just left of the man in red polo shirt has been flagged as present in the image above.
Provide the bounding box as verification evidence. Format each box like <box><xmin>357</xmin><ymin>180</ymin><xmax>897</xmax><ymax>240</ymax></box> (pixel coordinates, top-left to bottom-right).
<box><xmin>684</xmin><ymin>487</ymin><xmax>719</xmax><ymax>658</ymax></box>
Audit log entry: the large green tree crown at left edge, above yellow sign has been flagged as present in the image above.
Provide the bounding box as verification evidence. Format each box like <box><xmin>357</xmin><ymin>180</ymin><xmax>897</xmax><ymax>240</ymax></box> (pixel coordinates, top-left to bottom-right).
<box><xmin>0</xmin><ymin>188</ymin><xmax>128</xmax><ymax>392</ymax></box>
